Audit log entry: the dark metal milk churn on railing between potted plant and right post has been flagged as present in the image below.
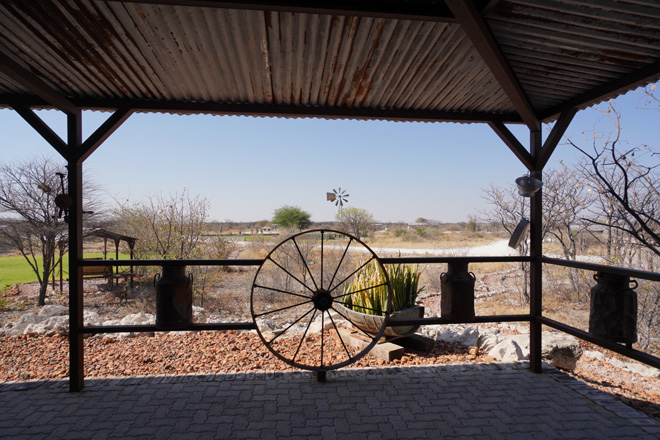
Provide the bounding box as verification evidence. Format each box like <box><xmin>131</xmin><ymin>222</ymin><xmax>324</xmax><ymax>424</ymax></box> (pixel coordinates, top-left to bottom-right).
<box><xmin>440</xmin><ymin>262</ymin><xmax>476</xmax><ymax>322</ymax></box>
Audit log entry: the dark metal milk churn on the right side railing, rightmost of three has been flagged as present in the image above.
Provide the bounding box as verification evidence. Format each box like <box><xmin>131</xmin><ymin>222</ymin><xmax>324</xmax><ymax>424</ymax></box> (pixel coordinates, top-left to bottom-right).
<box><xmin>589</xmin><ymin>272</ymin><xmax>637</xmax><ymax>345</ymax></box>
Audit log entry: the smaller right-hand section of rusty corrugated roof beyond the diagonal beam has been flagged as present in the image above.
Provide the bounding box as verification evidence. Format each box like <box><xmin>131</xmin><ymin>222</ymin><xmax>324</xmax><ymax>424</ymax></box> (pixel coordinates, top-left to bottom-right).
<box><xmin>487</xmin><ymin>0</ymin><xmax>660</xmax><ymax>110</ymax></box>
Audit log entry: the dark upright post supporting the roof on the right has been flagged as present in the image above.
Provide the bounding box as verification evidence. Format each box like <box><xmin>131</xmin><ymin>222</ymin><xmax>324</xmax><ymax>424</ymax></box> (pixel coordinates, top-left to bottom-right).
<box><xmin>529</xmin><ymin>130</ymin><xmax>543</xmax><ymax>373</ymax></box>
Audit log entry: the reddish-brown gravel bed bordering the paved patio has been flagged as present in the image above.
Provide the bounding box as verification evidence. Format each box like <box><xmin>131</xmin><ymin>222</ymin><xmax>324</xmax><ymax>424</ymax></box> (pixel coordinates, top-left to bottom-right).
<box><xmin>0</xmin><ymin>331</ymin><xmax>660</xmax><ymax>421</ymax></box>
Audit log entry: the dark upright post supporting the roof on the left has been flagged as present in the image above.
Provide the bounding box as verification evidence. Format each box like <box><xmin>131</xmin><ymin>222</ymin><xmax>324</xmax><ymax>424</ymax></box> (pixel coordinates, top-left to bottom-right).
<box><xmin>67</xmin><ymin>111</ymin><xmax>85</xmax><ymax>392</ymax></box>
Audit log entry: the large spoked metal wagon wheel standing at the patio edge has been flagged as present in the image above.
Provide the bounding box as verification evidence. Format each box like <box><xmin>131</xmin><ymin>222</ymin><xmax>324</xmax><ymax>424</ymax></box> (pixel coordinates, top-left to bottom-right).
<box><xmin>250</xmin><ymin>230</ymin><xmax>392</xmax><ymax>372</ymax></box>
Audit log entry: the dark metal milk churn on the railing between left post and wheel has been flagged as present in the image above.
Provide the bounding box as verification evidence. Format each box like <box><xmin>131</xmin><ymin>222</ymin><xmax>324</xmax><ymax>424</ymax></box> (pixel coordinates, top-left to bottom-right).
<box><xmin>154</xmin><ymin>266</ymin><xmax>193</xmax><ymax>330</ymax></box>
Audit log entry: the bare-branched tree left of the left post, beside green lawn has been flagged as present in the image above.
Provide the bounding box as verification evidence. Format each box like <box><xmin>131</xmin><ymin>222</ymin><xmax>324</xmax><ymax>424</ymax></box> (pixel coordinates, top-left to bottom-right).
<box><xmin>0</xmin><ymin>157</ymin><xmax>98</xmax><ymax>306</ymax></box>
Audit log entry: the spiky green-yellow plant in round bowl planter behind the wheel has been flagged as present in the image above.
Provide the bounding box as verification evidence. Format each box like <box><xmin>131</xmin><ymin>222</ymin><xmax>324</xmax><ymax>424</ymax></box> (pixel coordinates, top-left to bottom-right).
<box><xmin>340</xmin><ymin>261</ymin><xmax>424</xmax><ymax>337</ymax></box>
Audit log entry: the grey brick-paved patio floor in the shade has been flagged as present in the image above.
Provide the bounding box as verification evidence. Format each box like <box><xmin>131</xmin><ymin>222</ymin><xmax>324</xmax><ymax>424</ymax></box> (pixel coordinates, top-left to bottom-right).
<box><xmin>0</xmin><ymin>364</ymin><xmax>660</xmax><ymax>440</ymax></box>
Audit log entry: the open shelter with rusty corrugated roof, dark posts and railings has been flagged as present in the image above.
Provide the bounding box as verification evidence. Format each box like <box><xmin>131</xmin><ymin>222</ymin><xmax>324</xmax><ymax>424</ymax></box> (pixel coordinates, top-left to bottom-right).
<box><xmin>0</xmin><ymin>0</ymin><xmax>660</xmax><ymax>391</ymax></box>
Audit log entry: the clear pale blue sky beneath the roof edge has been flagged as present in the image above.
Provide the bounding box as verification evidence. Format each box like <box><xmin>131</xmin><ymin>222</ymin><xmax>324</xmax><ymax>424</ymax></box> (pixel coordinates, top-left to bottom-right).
<box><xmin>0</xmin><ymin>83</ymin><xmax>660</xmax><ymax>222</ymax></box>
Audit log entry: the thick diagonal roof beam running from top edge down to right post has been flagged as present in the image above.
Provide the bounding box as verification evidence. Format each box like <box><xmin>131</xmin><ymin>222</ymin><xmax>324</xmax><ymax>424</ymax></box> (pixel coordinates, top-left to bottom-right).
<box><xmin>446</xmin><ymin>0</ymin><xmax>541</xmax><ymax>131</ymax></box>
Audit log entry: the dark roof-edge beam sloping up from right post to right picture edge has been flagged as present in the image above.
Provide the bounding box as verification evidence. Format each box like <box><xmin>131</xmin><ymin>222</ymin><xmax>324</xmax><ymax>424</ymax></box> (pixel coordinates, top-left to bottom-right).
<box><xmin>541</xmin><ymin>61</ymin><xmax>660</xmax><ymax>120</ymax></box>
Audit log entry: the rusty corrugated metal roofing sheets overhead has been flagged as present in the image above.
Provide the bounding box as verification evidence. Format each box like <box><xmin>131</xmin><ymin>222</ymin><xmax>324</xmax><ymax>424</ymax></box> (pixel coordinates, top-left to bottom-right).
<box><xmin>0</xmin><ymin>0</ymin><xmax>660</xmax><ymax>120</ymax></box>
